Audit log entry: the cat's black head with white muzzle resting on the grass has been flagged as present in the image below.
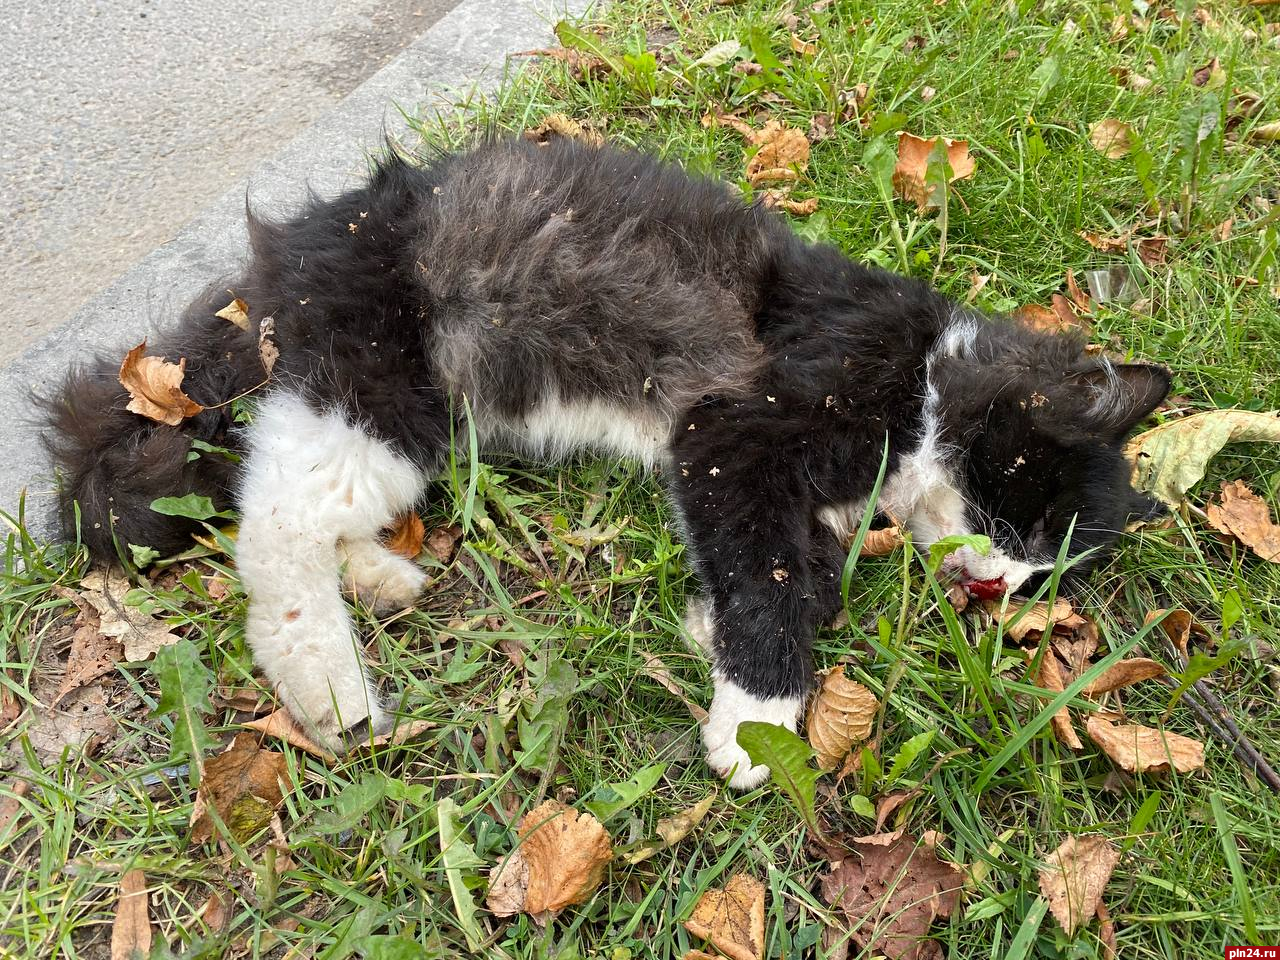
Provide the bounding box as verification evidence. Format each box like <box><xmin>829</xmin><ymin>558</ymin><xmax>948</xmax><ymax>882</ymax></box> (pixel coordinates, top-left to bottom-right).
<box><xmin>911</xmin><ymin>319</ymin><xmax>1170</xmax><ymax>594</ymax></box>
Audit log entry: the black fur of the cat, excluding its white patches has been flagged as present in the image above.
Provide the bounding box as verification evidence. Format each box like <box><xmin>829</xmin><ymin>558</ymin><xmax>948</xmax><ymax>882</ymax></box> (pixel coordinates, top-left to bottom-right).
<box><xmin>42</xmin><ymin>140</ymin><xmax>1169</xmax><ymax>721</ymax></box>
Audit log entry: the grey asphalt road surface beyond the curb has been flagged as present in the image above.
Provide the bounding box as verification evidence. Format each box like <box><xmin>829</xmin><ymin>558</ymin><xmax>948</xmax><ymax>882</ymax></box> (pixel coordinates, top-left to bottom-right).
<box><xmin>0</xmin><ymin>0</ymin><xmax>457</xmax><ymax>364</ymax></box>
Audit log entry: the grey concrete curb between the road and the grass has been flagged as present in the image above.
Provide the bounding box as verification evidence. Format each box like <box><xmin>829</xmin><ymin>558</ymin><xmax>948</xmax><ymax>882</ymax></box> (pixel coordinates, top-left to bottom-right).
<box><xmin>0</xmin><ymin>0</ymin><xmax>590</xmax><ymax>538</ymax></box>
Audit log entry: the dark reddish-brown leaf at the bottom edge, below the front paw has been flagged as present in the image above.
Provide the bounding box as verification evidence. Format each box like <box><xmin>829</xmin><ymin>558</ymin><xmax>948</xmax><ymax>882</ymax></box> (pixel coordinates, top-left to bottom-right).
<box><xmin>822</xmin><ymin>831</ymin><xmax>964</xmax><ymax>960</ymax></box>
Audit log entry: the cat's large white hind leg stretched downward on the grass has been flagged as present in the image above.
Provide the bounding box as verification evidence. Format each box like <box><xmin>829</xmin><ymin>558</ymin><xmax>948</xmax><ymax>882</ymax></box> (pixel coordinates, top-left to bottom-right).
<box><xmin>237</xmin><ymin>393</ymin><xmax>422</xmax><ymax>745</ymax></box>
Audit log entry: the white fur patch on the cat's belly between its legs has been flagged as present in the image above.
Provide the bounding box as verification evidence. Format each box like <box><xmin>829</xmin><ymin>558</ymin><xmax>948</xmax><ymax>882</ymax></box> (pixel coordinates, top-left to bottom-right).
<box><xmin>477</xmin><ymin>397</ymin><xmax>671</xmax><ymax>467</ymax></box>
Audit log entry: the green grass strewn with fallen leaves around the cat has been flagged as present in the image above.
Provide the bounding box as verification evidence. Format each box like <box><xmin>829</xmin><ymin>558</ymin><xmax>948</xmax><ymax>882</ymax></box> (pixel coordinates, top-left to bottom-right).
<box><xmin>0</xmin><ymin>0</ymin><xmax>1280</xmax><ymax>960</ymax></box>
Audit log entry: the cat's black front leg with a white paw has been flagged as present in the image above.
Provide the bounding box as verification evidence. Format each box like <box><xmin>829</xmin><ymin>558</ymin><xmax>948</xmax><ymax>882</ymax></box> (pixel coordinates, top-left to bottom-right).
<box><xmin>672</xmin><ymin>425</ymin><xmax>819</xmax><ymax>790</ymax></box>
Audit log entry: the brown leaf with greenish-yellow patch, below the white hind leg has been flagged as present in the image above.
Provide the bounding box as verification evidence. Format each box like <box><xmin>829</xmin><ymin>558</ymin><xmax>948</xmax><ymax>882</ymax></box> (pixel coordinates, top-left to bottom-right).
<box><xmin>191</xmin><ymin>731</ymin><xmax>291</xmax><ymax>844</ymax></box>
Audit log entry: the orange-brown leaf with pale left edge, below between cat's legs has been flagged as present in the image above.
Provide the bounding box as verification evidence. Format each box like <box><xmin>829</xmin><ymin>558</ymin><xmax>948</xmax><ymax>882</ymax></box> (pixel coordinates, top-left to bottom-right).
<box><xmin>486</xmin><ymin>800</ymin><xmax>613</xmax><ymax>924</ymax></box>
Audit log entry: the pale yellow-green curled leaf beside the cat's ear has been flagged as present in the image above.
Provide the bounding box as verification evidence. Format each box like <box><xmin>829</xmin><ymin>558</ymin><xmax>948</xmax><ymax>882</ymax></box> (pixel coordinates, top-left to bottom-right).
<box><xmin>1124</xmin><ymin>410</ymin><xmax>1280</xmax><ymax>507</ymax></box>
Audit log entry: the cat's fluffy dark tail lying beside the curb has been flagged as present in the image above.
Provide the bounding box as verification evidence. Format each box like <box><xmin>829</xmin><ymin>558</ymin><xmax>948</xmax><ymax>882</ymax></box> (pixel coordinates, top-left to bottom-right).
<box><xmin>37</xmin><ymin>285</ymin><xmax>262</xmax><ymax>558</ymax></box>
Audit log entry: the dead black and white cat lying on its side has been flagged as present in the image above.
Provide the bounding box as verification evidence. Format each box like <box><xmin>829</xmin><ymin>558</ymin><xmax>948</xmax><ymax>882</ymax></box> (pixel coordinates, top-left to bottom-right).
<box><xmin>49</xmin><ymin>140</ymin><xmax>1169</xmax><ymax>787</ymax></box>
